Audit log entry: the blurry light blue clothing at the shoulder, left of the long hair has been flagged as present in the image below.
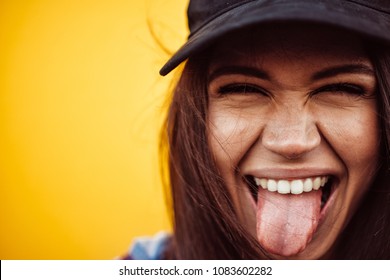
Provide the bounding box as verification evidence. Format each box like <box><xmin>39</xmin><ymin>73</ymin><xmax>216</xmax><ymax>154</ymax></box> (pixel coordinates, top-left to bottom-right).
<box><xmin>125</xmin><ymin>232</ymin><xmax>170</xmax><ymax>260</ymax></box>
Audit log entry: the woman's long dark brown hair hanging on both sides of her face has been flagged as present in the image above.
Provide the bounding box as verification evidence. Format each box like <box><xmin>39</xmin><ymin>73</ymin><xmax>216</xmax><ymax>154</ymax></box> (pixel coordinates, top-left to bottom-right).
<box><xmin>160</xmin><ymin>40</ymin><xmax>390</xmax><ymax>259</ymax></box>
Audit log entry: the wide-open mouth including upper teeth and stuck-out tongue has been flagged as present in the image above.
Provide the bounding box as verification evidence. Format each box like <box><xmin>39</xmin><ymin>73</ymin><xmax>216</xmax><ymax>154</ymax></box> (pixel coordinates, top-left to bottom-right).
<box><xmin>244</xmin><ymin>174</ymin><xmax>337</xmax><ymax>257</ymax></box>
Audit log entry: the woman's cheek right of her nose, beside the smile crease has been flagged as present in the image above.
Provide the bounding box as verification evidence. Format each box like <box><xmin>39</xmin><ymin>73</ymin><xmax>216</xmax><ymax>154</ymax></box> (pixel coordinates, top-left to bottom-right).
<box><xmin>322</xmin><ymin>104</ymin><xmax>380</xmax><ymax>198</ymax></box>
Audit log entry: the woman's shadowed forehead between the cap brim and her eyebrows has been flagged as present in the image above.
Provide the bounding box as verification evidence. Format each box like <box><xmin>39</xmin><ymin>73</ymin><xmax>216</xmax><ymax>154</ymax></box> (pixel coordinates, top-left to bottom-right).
<box><xmin>210</xmin><ymin>23</ymin><xmax>367</xmax><ymax>68</ymax></box>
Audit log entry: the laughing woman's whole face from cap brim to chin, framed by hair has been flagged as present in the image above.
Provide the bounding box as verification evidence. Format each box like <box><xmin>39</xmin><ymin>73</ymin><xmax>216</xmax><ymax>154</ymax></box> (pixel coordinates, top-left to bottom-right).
<box><xmin>208</xmin><ymin>25</ymin><xmax>379</xmax><ymax>259</ymax></box>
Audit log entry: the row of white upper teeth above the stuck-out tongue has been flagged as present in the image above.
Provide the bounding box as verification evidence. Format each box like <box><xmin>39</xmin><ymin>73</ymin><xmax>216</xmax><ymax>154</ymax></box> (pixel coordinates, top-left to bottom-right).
<box><xmin>254</xmin><ymin>176</ymin><xmax>329</xmax><ymax>194</ymax></box>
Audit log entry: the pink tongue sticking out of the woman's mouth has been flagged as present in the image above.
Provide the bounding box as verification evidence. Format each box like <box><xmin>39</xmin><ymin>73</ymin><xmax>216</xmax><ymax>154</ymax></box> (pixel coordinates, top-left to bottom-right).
<box><xmin>256</xmin><ymin>188</ymin><xmax>322</xmax><ymax>257</ymax></box>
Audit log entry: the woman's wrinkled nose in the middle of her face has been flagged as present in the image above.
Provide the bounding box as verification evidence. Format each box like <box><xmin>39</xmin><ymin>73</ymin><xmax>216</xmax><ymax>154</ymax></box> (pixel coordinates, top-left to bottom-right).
<box><xmin>261</xmin><ymin>109</ymin><xmax>321</xmax><ymax>159</ymax></box>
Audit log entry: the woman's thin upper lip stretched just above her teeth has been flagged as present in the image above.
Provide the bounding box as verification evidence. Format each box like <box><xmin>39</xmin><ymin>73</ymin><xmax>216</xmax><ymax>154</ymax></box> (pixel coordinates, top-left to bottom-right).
<box><xmin>244</xmin><ymin>167</ymin><xmax>337</xmax><ymax>180</ymax></box>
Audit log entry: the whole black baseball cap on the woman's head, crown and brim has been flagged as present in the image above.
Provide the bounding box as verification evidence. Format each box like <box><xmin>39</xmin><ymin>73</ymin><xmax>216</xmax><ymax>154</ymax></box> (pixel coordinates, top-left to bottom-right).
<box><xmin>160</xmin><ymin>0</ymin><xmax>390</xmax><ymax>76</ymax></box>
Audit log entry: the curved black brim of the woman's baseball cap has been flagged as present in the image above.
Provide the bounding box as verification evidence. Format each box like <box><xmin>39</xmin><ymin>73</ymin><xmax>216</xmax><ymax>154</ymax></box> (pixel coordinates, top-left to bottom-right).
<box><xmin>160</xmin><ymin>0</ymin><xmax>390</xmax><ymax>76</ymax></box>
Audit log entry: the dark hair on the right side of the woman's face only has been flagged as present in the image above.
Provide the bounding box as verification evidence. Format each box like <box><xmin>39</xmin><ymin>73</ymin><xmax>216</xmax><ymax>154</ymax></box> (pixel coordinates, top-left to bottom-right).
<box><xmin>334</xmin><ymin>43</ymin><xmax>390</xmax><ymax>260</ymax></box>
